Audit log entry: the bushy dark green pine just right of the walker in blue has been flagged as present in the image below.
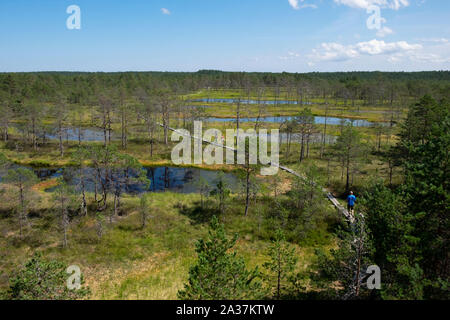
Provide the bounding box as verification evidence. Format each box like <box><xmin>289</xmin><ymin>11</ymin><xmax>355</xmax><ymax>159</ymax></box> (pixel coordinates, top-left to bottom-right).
<box><xmin>361</xmin><ymin>182</ymin><xmax>423</xmax><ymax>299</ymax></box>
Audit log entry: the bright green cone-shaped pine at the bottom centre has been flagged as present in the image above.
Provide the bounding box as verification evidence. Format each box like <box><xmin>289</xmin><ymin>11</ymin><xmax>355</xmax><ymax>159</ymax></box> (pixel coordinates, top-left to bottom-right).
<box><xmin>178</xmin><ymin>216</ymin><xmax>261</xmax><ymax>300</ymax></box>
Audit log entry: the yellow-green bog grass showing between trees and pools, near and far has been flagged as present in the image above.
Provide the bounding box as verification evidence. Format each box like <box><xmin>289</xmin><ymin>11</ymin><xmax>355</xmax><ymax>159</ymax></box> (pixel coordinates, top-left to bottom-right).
<box><xmin>0</xmin><ymin>91</ymin><xmax>408</xmax><ymax>299</ymax></box>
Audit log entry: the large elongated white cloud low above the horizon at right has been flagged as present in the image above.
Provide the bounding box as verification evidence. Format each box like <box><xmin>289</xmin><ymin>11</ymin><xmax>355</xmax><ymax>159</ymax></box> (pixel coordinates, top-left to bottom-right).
<box><xmin>308</xmin><ymin>39</ymin><xmax>422</xmax><ymax>61</ymax></box>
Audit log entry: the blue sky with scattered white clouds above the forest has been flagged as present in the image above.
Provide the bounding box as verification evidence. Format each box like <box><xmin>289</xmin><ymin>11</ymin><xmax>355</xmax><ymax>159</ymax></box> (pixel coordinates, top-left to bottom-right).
<box><xmin>0</xmin><ymin>0</ymin><xmax>450</xmax><ymax>72</ymax></box>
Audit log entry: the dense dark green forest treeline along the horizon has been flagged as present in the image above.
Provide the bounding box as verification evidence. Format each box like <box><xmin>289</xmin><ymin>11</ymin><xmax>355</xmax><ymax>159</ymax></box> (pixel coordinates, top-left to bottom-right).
<box><xmin>0</xmin><ymin>70</ymin><xmax>450</xmax><ymax>103</ymax></box>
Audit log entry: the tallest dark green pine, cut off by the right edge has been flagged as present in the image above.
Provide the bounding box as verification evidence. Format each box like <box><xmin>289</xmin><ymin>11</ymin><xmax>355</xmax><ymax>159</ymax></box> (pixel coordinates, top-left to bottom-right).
<box><xmin>397</xmin><ymin>96</ymin><xmax>450</xmax><ymax>299</ymax></box>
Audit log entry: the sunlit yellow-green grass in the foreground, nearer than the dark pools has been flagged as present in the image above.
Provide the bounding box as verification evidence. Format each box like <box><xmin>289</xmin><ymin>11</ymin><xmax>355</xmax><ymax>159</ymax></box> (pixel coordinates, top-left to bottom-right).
<box><xmin>0</xmin><ymin>184</ymin><xmax>336</xmax><ymax>299</ymax></box>
